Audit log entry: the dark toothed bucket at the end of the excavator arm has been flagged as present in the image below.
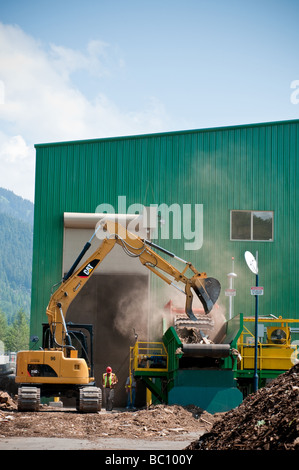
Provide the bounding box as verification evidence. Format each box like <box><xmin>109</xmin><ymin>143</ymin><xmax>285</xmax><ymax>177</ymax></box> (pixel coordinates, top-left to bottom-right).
<box><xmin>186</xmin><ymin>276</ymin><xmax>221</xmax><ymax>321</ymax></box>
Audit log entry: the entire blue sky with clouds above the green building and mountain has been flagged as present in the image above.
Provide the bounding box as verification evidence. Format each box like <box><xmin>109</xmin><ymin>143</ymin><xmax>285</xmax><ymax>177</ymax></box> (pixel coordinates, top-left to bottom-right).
<box><xmin>0</xmin><ymin>0</ymin><xmax>299</xmax><ymax>200</ymax></box>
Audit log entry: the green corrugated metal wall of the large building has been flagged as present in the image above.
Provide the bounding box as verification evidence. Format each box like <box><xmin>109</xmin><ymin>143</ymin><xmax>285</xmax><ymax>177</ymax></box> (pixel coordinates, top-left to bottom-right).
<box><xmin>31</xmin><ymin>117</ymin><xmax>299</xmax><ymax>333</ymax></box>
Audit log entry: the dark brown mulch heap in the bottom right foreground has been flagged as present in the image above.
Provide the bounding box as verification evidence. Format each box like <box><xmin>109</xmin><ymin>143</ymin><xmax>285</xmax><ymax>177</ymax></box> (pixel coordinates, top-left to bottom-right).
<box><xmin>187</xmin><ymin>364</ymin><xmax>299</xmax><ymax>450</ymax></box>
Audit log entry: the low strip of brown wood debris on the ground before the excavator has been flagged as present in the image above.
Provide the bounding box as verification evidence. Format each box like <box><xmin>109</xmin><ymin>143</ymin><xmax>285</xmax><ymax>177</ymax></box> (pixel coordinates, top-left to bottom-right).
<box><xmin>0</xmin><ymin>402</ymin><xmax>214</xmax><ymax>440</ymax></box>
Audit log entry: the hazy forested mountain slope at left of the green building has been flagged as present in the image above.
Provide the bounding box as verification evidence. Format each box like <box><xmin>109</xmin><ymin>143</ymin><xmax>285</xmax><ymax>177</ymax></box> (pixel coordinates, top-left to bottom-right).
<box><xmin>0</xmin><ymin>188</ymin><xmax>34</xmax><ymax>323</ymax></box>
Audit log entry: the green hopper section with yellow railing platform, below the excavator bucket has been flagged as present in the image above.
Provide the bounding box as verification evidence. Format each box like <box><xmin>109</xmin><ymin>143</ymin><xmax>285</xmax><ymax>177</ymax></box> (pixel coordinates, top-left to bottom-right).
<box><xmin>130</xmin><ymin>318</ymin><xmax>243</xmax><ymax>413</ymax></box>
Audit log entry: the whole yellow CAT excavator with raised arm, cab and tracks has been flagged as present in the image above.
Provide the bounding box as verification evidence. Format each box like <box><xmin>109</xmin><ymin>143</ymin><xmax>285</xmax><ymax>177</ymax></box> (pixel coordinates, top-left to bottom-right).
<box><xmin>15</xmin><ymin>220</ymin><xmax>220</xmax><ymax>412</ymax></box>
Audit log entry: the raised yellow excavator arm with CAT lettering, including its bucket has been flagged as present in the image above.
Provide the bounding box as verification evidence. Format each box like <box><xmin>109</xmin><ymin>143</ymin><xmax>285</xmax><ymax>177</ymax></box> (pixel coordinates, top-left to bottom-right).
<box><xmin>46</xmin><ymin>221</ymin><xmax>220</xmax><ymax>348</ymax></box>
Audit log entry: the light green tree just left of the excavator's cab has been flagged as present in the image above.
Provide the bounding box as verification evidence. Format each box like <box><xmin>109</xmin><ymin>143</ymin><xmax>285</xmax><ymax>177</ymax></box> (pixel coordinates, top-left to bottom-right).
<box><xmin>6</xmin><ymin>309</ymin><xmax>29</xmax><ymax>352</ymax></box>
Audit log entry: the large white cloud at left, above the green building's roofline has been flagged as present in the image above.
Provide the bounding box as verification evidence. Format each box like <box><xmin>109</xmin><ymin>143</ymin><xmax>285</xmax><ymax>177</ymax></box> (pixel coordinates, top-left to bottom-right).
<box><xmin>0</xmin><ymin>23</ymin><xmax>171</xmax><ymax>199</ymax></box>
